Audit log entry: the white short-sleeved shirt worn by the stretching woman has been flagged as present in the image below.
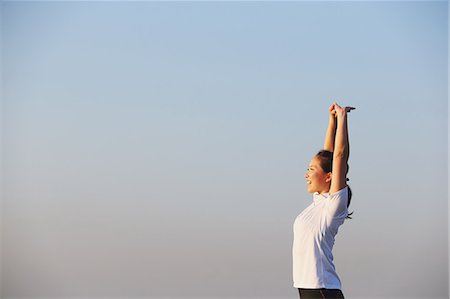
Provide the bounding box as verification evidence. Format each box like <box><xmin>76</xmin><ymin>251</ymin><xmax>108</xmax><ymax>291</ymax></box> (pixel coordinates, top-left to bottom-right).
<box><xmin>292</xmin><ymin>186</ymin><xmax>348</xmax><ymax>289</ymax></box>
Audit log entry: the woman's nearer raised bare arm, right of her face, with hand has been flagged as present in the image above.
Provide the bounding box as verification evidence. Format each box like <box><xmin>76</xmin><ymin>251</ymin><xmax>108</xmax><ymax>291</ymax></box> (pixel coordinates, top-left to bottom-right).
<box><xmin>330</xmin><ymin>104</ymin><xmax>355</xmax><ymax>194</ymax></box>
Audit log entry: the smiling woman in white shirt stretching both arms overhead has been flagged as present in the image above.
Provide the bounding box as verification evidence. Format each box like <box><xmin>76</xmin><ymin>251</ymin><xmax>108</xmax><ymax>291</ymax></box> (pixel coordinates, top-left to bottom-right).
<box><xmin>292</xmin><ymin>103</ymin><xmax>355</xmax><ymax>299</ymax></box>
